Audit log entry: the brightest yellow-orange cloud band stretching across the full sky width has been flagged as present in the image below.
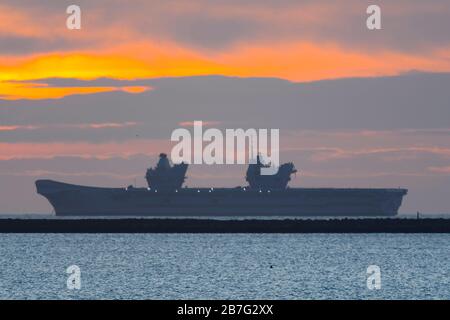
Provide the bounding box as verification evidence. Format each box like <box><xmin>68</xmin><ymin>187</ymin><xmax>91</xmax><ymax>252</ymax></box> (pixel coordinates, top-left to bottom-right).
<box><xmin>0</xmin><ymin>43</ymin><xmax>450</xmax><ymax>88</ymax></box>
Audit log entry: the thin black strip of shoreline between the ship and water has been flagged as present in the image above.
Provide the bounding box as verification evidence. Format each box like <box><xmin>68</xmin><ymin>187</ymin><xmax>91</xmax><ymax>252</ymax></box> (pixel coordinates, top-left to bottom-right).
<box><xmin>0</xmin><ymin>218</ymin><xmax>450</xmax><ymax>233</ymax></box>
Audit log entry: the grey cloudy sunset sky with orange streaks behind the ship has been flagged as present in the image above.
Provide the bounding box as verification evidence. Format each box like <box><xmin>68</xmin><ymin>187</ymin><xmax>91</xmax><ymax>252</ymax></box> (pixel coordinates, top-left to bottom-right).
<box><xmin>0</xmin><ymin>0</ymin><xmax>450</xmax><ymax>213</ymax></box>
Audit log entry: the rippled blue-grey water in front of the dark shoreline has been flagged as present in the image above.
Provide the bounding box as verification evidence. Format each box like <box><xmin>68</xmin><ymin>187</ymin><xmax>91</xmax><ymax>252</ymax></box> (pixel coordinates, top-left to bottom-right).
<box><xmin>0</xmin><ymin>234</ymin><xmax>450</xmax><ymax>299</ymax></box>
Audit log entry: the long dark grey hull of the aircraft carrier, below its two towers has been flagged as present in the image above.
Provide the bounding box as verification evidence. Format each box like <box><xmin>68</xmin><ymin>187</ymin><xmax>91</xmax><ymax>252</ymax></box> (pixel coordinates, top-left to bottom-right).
<box><xmin>36</xmin><ymin>180</ymin><xmax>407</xmax><ymax>217</ymax></box>
